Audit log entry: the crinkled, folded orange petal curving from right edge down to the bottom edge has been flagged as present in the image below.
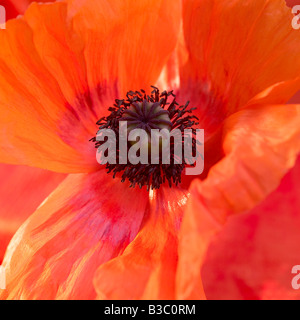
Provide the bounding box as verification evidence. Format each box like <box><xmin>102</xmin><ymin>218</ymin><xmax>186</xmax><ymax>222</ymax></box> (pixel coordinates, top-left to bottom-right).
<box><xmin>177</xmin><ymin>105</ymin><xmax>300</xmax><ymax>299</ymax></box>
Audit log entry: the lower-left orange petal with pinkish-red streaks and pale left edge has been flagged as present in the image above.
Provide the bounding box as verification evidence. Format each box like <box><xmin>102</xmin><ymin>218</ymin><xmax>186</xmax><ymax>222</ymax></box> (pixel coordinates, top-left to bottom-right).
<box><xmin>0</xmin><ymin>171</ymin><xmax>148</xmax><ymax>300</ymax></box>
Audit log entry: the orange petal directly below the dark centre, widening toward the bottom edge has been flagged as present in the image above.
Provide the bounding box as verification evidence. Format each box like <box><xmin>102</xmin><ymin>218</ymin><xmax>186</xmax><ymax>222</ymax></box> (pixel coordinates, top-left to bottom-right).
<box><xmin>94</xmin><ymin>187</ymin><xmax>188</xmax><ymax>300</ymax></box>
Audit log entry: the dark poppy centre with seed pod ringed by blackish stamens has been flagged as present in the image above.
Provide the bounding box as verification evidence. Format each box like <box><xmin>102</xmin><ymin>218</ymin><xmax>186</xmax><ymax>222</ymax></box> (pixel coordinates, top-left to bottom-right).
<box><xmin>90</xmin><ymin>87</ymin><xmax>198</xmax><ymax>190</ymax></box>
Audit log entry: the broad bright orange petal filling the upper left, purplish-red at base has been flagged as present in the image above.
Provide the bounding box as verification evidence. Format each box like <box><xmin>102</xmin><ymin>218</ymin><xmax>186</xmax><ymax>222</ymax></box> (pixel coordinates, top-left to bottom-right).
<box><xmin>0</xmin><ymin>0</ymin><xmax>180</xmax><ymax>173</ymax></box>
